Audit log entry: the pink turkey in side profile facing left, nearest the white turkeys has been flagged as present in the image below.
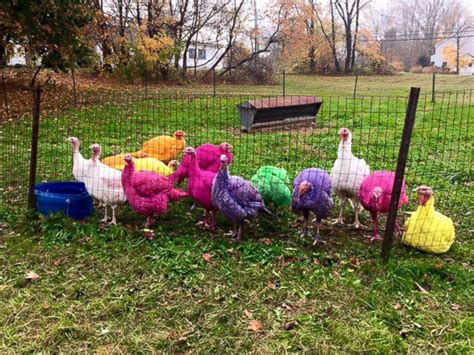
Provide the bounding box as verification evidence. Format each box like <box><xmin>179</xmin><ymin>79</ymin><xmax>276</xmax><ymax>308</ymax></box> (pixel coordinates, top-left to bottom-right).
<box><xmin>122</xmin><ymin>155</ymin><xmax>188</xmax><ymax>228</ymax></box>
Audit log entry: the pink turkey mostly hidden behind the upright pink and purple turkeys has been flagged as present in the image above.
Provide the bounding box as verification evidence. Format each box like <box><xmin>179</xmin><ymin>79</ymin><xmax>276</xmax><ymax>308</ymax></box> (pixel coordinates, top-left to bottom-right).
<box><xmin>171</xmin><ymin>142</ymin><xmax>233</xmax><ymax>183</ymax></box>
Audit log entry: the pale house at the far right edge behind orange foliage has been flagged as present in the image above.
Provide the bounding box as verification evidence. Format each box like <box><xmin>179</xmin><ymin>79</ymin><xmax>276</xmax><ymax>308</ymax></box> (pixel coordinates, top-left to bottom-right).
<box><xmin>431</xmin><ymin>37</ymin><xmax>474</xmax><ymax>75</ymax></box>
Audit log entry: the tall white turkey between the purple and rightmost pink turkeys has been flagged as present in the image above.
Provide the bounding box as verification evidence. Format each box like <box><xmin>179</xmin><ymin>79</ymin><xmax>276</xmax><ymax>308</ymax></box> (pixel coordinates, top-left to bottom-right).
<box><xmin>331</xmin><ymin>128</ymin><xmax>370</xmax><ymax>228</ymax></box>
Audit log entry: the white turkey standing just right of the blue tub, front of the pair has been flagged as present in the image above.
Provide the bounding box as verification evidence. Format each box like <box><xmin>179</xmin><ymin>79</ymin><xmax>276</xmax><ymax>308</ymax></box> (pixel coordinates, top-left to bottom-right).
<box><xmin>84</xmin><ymin>144</ymin><xmax>127</xmax><ymax>224</ymax></box>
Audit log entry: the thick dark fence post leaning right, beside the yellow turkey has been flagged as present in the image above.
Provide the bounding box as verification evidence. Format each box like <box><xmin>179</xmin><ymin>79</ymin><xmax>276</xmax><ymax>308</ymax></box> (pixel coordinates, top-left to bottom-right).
<box><xmin>381</xmin><ymin>87</ymin><xmax>420</xmax><ymax>262</ymax></box>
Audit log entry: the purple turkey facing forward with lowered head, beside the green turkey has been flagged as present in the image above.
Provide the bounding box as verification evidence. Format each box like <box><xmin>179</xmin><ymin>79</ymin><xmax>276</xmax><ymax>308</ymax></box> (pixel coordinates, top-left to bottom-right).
<box><xmin>291</xmin><ymin>168</ymin><xmax>333</xmax><ymax>244</ymax></box>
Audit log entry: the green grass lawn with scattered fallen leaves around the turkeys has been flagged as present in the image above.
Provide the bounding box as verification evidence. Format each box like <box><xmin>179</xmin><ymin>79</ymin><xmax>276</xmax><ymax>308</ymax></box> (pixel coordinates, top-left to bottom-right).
<box><xmin>0</xmin><ymin>75</ymin><xmax>474</xmax><ymax>353</ymax></box>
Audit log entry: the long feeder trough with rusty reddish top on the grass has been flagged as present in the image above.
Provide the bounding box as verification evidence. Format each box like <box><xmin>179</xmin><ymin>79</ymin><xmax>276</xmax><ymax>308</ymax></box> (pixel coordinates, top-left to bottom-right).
<box><xmin>237</xmin><ymin>96</ymin><xmax>323</xmax><ymax>132</ymax></box>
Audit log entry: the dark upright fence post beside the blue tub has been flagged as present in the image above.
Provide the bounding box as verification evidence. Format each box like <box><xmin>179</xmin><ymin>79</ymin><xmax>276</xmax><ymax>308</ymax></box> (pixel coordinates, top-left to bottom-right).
<box><xmin>28</xmin><ymin>86</ymin><xmax>41</xmax><ymax>208</ymax></box>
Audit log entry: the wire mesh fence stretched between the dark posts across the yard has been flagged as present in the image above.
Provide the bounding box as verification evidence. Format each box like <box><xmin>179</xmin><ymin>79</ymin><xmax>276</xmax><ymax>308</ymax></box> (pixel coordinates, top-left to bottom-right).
<box><xmin>0</xmin><ymin>85</ymin><xmax>474</xmax><ymax>253</ymax></box>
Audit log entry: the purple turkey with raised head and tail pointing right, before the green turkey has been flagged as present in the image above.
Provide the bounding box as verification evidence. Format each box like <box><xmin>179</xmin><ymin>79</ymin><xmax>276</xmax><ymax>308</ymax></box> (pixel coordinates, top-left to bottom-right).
<box><xmin>212</xmin><ymin>155</ymin><xmax>272</xmax><ymax>240</ymax></box>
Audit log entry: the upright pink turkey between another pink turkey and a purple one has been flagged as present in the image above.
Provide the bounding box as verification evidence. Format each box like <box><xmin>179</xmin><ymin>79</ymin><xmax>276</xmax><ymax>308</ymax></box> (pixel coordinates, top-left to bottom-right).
<box><xmin>183</xmin><ymin>147</ymin><xmax>216</xmax><ymax>229</ymax></box>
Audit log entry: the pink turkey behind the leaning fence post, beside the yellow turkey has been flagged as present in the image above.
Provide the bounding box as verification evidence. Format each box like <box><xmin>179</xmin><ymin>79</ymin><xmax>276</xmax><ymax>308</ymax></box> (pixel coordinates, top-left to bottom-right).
<box><xmin>359</xmin><ymin>170</ymin><xmax>408</xmax><ymax>241</ymax></box>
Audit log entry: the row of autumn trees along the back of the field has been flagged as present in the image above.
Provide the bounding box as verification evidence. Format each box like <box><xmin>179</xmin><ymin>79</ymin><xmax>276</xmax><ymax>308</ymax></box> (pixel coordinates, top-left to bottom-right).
<box><xmin>0</xmin><ymin>0</ymin><xmax>473</xmax><ymax>80</ymax></box>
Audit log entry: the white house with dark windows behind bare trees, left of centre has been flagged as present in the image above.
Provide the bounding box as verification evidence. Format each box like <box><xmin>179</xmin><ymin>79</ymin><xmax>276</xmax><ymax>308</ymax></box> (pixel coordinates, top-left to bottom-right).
<box><xmin>179</xmin><ymin>42</ymin><xmax>223</xmax><ymax>70</ymax></box>
